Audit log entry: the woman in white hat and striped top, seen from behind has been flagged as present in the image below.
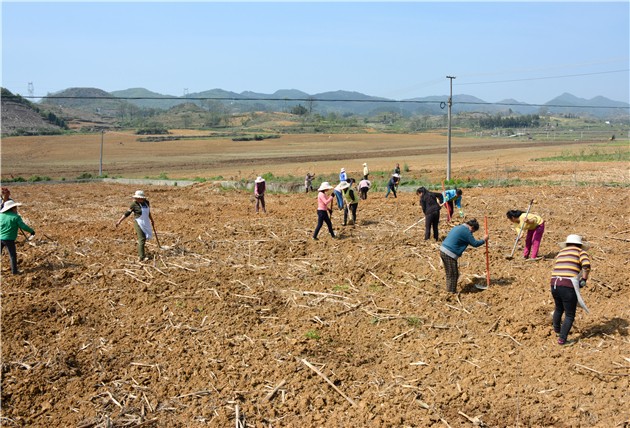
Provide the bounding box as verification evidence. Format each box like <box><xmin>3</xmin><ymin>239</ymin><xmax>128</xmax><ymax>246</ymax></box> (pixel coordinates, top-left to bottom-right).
<box><xmin>551</xmin><ymin>235</ymin><xmax>591</xmax><ymax>345</ymax></box>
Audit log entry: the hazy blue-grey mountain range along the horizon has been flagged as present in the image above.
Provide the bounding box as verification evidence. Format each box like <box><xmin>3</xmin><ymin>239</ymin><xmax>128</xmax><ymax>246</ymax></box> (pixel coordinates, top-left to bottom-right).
<box><xmin>30</xmin><ymin>88</ymin><xmax>630</xmax><ymax>118</ymax></box>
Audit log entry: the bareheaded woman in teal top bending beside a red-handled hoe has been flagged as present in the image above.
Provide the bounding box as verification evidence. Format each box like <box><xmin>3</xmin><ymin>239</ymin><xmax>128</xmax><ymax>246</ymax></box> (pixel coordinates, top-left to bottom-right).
<box><xmin>440</xmin><ymin>219</ymin><xmax>488</xmax><ymax>293</ymax></box>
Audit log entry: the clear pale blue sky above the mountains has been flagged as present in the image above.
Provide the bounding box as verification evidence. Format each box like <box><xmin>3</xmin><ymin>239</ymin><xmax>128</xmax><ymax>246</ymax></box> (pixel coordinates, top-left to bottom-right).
<box><xmin>2</xmin><ymin>1</ymin><xmax>630</xmax><ymax>104</ymax></box>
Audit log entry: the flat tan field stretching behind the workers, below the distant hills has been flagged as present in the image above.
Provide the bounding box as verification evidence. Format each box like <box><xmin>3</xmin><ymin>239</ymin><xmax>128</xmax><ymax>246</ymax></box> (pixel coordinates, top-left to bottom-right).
<box><xmin>1</xmin><ymin>130</ymin><xmax>629</xmax><ymax>184</ymax></box>
